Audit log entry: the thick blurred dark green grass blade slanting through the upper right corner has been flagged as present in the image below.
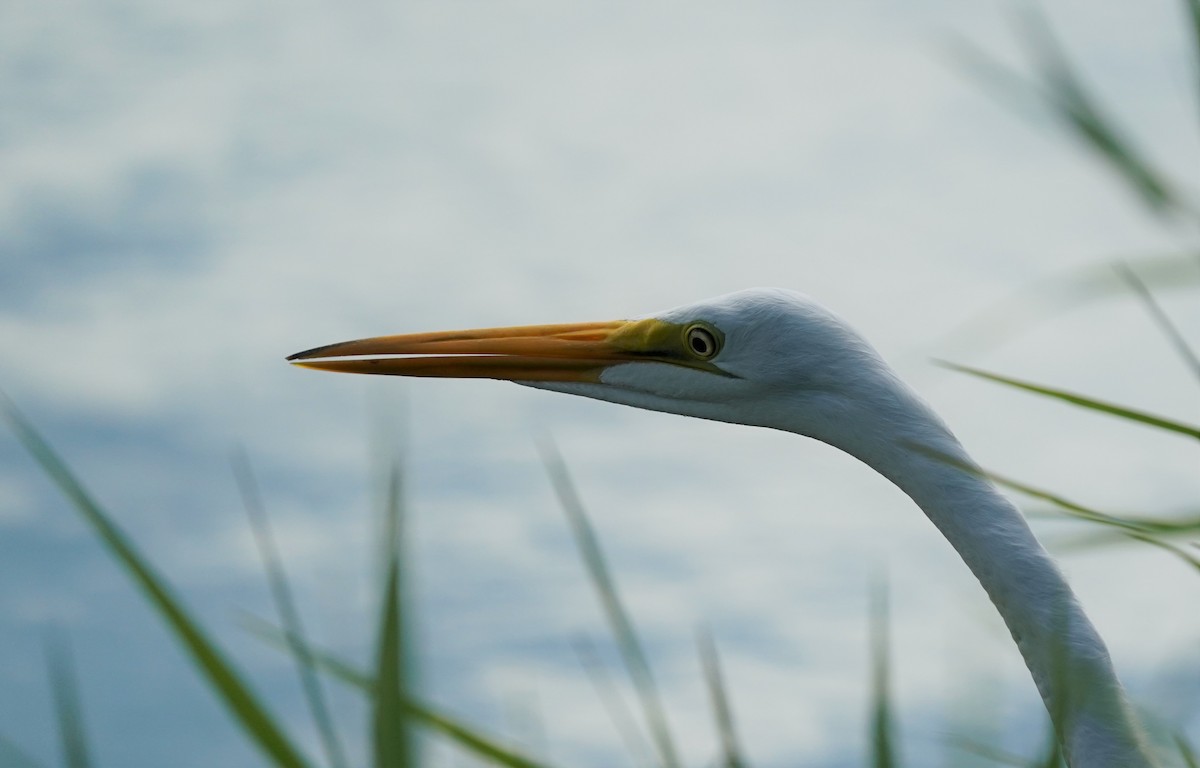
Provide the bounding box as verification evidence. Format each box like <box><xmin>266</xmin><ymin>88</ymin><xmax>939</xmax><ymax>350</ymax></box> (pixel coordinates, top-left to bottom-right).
<box><xmin>1021</xmin><ymin>12</ymin><xmax>1192</xmax><ymax>216</ymax></box>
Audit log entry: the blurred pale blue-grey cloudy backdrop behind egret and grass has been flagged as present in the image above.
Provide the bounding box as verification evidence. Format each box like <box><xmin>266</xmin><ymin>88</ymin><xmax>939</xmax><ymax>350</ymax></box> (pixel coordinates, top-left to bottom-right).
<box><xmin>0</xmin><ymin>0</ymin><xmax>1200</xmax><ymax>768</ymax></box>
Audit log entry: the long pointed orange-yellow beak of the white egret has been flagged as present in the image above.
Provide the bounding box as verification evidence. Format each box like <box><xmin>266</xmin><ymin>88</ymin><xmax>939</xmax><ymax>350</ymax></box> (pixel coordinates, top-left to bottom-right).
<box><xmin>288</xmin><ymin>319</ymin><xmax>677</xmax><ymax>382</ymax></box>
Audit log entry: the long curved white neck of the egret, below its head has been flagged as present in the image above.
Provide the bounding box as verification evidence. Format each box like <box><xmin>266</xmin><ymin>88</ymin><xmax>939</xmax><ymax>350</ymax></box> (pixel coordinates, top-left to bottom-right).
<box><xmin>822</xmin><ymin>377</ymin><xmax>1154</xmax><ymax>768</ymax></box>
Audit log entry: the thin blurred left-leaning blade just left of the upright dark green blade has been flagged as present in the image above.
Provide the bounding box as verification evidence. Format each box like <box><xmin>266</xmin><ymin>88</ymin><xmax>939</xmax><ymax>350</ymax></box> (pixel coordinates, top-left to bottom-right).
<box><xmin>232</xmin><ymin>450</ymin><xmax>347</xmax><ymax>768</ymax></box>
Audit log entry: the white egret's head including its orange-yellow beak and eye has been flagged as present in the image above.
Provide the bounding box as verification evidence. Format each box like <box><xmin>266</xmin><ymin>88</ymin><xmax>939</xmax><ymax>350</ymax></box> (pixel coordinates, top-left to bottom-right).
<box><xmin>288</xmin><ymin>288</ymin><xmax>887</xmax><ymax>439</ymax></box>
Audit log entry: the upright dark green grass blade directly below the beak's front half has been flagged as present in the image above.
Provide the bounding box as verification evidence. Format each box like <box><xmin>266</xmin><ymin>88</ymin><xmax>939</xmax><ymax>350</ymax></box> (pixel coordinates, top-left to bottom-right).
<box><xmin>371</xmin><ymin>464</ymin><xmax>416</xmax><ymax>768</ymax></box>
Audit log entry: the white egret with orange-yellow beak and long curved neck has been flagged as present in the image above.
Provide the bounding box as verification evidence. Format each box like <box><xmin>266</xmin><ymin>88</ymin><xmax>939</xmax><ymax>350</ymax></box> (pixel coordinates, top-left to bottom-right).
<box><xmin>288</xmin><ymin>289</ymin><xmax>1153</xmax><ymax>768</ymax></box>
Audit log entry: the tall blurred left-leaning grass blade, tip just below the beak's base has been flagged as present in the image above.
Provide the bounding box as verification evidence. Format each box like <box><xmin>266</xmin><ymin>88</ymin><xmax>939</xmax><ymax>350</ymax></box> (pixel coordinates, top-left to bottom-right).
<box><xmin>539</xmin><ymin>439</ymin><xmax>679</xmax><ymax>768</ymax></box>
